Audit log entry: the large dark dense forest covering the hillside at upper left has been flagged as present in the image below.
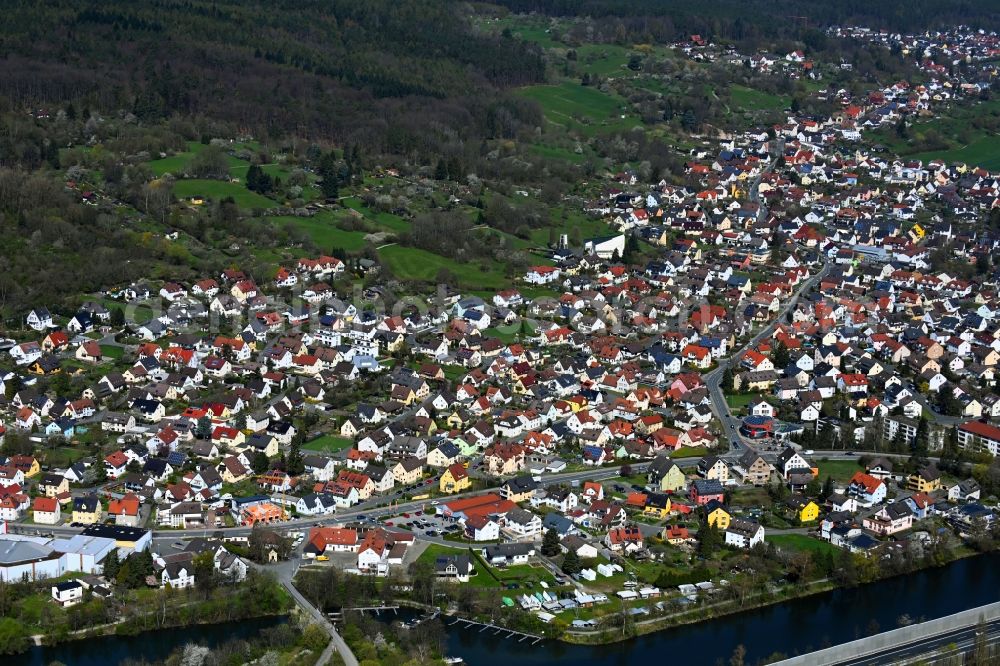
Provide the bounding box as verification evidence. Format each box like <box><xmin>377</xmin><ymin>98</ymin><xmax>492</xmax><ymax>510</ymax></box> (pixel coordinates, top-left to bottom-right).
<box><xmin>0</xmin><ymin>0</ymin><xmax>544</xmax><ymax>155</ymax></box>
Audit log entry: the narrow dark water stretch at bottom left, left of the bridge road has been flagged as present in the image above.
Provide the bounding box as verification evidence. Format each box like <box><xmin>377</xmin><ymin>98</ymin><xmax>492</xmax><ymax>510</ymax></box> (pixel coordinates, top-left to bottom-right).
<box><xmin>14</xmin><ymin>616</ymin><xmax>288</xmax><ymax>666</ymax></box>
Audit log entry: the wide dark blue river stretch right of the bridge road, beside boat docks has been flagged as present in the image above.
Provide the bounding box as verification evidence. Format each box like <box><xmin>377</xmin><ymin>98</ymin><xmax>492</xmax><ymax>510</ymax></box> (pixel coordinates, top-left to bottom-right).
<box><xmin>448</xmin><ymin>553</ymin><xmax>1000</xmax><ymax>666</ymax></box>
